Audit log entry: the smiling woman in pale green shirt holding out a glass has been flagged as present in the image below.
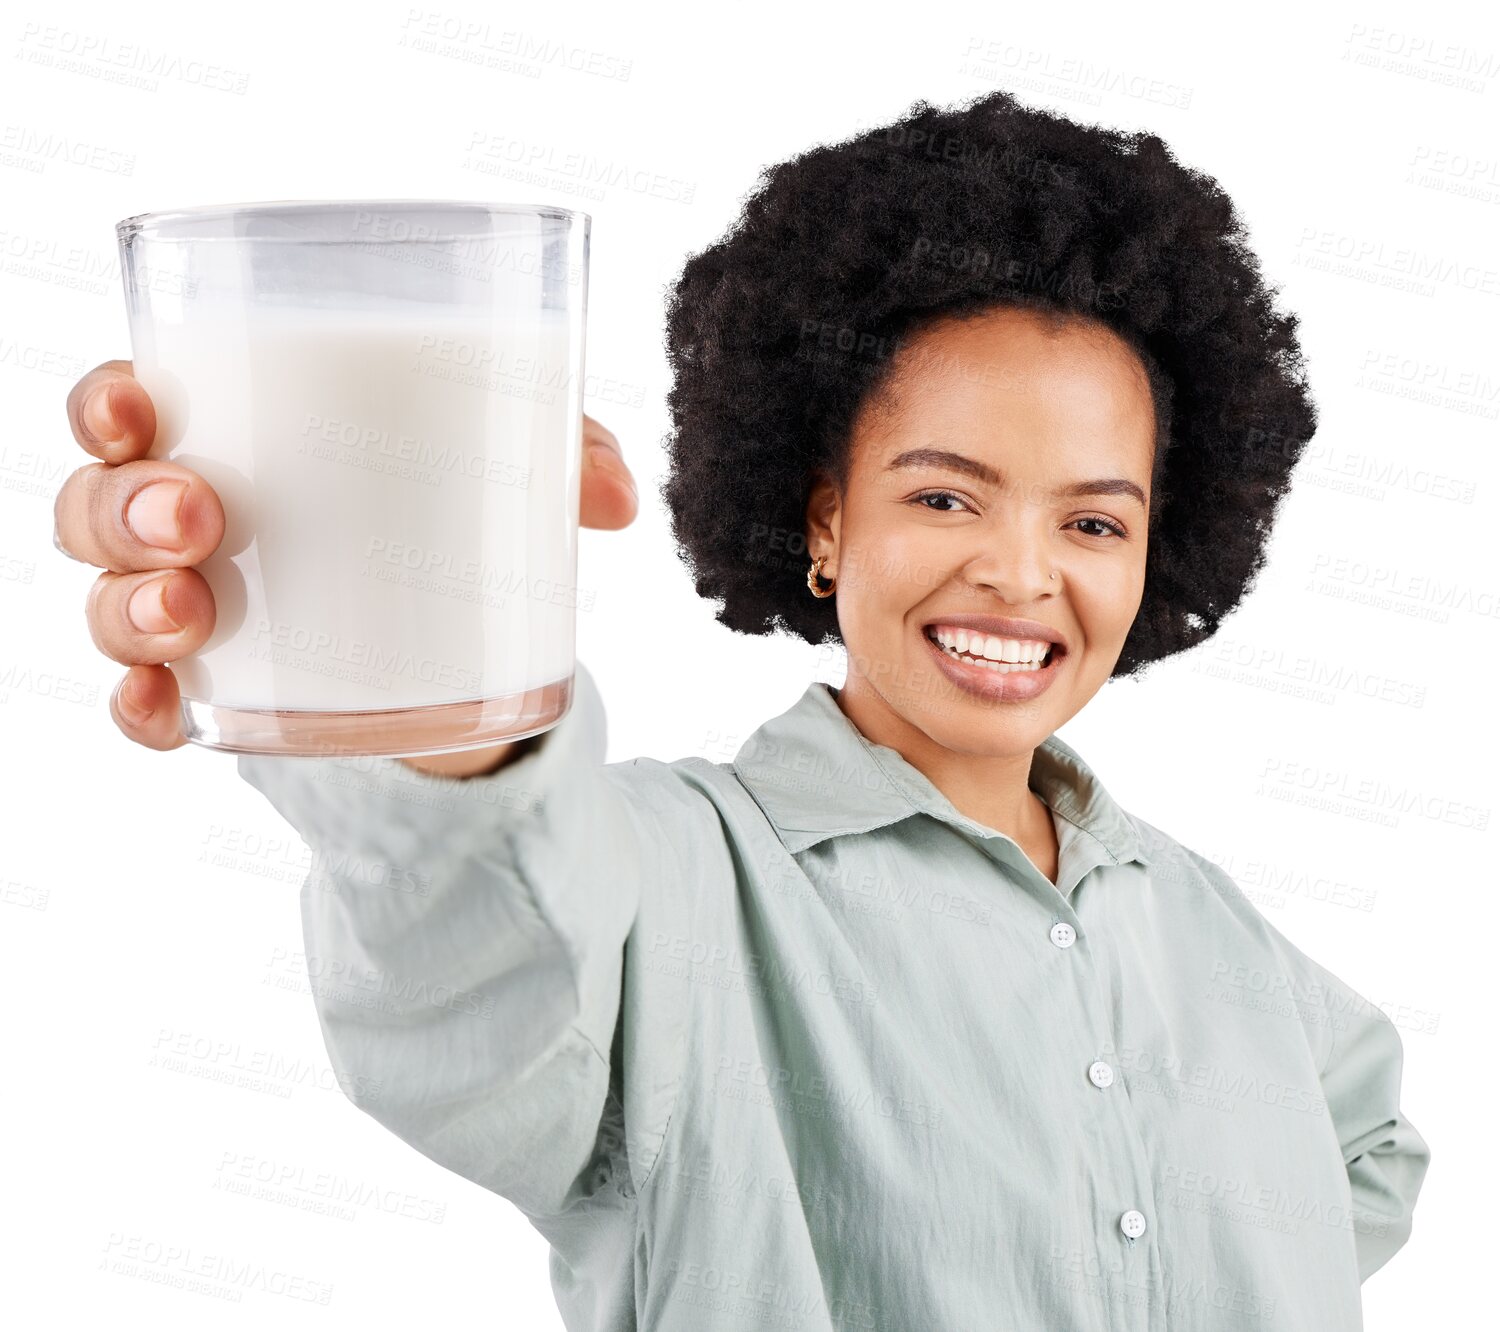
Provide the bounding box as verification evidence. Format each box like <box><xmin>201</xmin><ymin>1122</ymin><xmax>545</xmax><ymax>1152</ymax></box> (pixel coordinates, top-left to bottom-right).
<box><xmin>59</xmin><ymin>93</ymin><xmax>1430</xmax><ymax>1332</ymax></box>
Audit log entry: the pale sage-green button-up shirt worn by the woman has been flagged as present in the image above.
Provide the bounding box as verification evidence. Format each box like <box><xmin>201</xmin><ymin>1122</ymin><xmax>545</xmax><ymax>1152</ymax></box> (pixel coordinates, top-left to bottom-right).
<box><xmin>239</xmin><ymin>666</ymin><xmax>1430</xmax><ymax>1332</ymax></box>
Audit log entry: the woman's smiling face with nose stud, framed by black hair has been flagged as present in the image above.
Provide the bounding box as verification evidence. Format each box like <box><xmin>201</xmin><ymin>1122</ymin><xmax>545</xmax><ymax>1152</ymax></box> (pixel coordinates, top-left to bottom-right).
<box><xmin>807</xmin><ymin>308</ymin><xmax>1155</xmax><ymax>758</ymax></box>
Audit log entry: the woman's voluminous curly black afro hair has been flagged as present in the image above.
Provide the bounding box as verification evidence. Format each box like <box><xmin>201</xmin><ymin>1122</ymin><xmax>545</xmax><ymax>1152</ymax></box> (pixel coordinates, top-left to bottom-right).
<box><xmin>662</xmin><ymin>92</ymin><xmax>1317</xmax><ymax>677</ymax></box>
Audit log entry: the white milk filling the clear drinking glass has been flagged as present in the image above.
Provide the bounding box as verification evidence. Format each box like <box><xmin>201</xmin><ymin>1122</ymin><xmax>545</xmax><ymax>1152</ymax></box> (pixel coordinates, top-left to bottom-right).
<box><xmin>135</xmin><ymin>305</ymin><xmax>582</xmax><ymax>713</ymax></box>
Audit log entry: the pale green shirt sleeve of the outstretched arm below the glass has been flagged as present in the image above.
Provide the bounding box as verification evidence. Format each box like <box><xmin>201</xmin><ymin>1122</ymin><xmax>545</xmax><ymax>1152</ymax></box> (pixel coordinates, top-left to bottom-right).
<box><xmin>239</xmin><ymin>663</ymin><xmax>657</xmax><ymax>1218</ymax></box>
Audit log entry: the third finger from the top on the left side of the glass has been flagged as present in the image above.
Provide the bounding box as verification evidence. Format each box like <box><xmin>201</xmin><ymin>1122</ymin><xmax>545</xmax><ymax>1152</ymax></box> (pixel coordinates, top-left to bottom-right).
<box><xmin>86</xmin><ymin>569</ymin><xmax>216</xmax><ymax>666</ymax></box>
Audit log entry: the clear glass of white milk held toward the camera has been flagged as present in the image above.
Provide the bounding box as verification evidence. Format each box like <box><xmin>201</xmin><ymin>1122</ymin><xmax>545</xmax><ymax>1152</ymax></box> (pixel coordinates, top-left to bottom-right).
<box><xmin>117</xmin><ymin>200</ymin><xmax>590</xmax><ymax>756</ymax></box>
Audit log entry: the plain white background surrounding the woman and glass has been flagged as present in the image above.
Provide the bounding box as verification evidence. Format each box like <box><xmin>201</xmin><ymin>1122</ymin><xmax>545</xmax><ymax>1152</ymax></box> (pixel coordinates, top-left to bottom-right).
<box><xmin>0</xmin><ymin>0</ymin><xmax>1500</xmax><ymax>1332</ymax></box>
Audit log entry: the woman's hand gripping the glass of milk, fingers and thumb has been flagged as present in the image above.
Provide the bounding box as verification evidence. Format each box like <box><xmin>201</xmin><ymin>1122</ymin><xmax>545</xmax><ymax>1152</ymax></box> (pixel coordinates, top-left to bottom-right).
<box><xmin>53</xmin><ymin>360</ymin><xmax>639</xmax><ymax>759</ymax></box>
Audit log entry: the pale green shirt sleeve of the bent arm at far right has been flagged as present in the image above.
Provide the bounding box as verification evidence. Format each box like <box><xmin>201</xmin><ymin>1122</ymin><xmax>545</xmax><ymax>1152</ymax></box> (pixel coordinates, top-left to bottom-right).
<box><xmin>1278</xmin><ymin>936</ymin><xmax>1431</xmax><ymax>1283</ymax></box>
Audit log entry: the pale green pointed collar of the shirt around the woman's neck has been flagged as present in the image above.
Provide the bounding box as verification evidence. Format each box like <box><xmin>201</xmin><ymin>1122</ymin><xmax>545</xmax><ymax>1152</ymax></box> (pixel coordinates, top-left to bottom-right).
<box><xmin>732</xmin><ymin>680</ymin><xmax>1151</xmax><ymax>864</ymax></box>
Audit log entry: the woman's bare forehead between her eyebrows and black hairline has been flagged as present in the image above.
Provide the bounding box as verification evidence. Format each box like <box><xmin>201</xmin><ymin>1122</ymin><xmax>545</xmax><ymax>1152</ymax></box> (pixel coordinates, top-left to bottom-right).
<box><xmin>854</xmin><ymin>309</ymin><xmax>1155</xmax><ymax>473</ymax></box>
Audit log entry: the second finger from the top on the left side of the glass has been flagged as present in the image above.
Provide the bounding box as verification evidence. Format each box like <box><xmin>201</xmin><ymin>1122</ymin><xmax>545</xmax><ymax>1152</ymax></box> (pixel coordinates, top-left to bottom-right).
<box><xmin>53</xmin><ymin>458</ymin><xmax>224</xmax><ymax>573</ymax></box>
